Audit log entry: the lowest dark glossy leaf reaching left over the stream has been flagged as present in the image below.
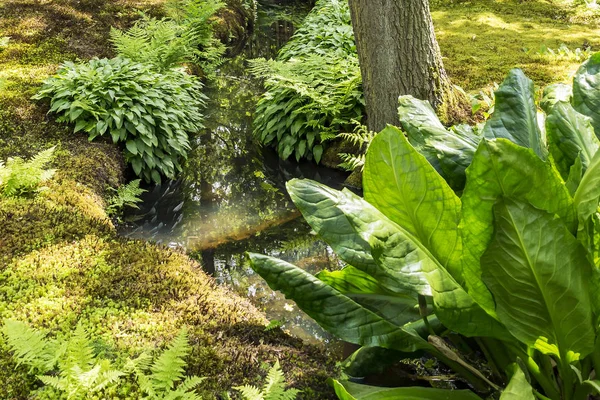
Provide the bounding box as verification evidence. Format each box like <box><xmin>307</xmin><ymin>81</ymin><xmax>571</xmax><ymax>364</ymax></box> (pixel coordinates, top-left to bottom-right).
<box><xmin>250</xmin><ymin>254</ymin><xmax>430</xmax><ymax>351</ymax></box>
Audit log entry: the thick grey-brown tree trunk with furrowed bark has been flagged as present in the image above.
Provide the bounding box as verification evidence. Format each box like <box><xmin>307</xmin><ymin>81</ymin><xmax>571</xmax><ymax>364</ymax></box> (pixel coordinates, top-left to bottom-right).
<box><xmin>349</xmin><ymin>0</ymin><xmax>453</xmax><ymax>132</ymax></box>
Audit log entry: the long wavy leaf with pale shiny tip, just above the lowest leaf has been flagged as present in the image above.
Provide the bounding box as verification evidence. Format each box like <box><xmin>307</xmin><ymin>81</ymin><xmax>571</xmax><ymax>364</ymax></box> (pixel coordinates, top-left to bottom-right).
<box><xmin>288</xmin><ymin>180</ymin><xmax>508</xmax><ymax>338</ymax></box>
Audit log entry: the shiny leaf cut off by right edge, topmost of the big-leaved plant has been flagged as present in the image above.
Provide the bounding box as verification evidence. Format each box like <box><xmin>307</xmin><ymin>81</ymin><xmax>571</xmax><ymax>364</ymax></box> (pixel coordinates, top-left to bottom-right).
<box><xmin>573</xmin><ymin>53</ymin><xmax>600</xmax><ymax>136</ymax></box>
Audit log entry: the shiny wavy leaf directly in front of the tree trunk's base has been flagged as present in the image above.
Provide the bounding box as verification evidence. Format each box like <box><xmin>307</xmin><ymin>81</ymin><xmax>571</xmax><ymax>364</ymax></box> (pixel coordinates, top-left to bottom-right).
<box><xmin>398</xmin><ymin>96</ymin><xmax>480</xmax><ymax>190</ymax></box>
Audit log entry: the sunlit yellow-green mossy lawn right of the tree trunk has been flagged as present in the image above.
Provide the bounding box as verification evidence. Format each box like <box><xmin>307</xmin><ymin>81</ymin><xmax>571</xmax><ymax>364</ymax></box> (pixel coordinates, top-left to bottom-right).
<box><xmin>432</xmin><ymin>0</ymin><xmax>600</xmax><ymax>91</ymax></box>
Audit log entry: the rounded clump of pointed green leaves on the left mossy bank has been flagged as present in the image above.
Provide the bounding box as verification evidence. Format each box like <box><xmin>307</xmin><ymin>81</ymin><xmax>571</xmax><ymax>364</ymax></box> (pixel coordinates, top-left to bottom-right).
<box><xmin>35</xmin><ymin>57</ymin><xmax>205</xmax><ymax>182</ymax></box>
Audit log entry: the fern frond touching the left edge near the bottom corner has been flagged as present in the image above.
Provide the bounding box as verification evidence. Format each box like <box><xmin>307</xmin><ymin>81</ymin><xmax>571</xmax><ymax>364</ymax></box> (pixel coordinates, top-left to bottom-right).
<box><xmin>2</xmin><ymin>320</ymin><xmax>58</xmax><ymax>374</ymax></box>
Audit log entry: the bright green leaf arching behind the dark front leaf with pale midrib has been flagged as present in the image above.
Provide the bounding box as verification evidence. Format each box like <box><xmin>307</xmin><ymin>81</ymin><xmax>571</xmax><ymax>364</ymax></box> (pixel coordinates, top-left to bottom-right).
<box><xmin>461</xmin><ymin>139</ymin><xmax>577</xmax><ymax>312</ymax></box>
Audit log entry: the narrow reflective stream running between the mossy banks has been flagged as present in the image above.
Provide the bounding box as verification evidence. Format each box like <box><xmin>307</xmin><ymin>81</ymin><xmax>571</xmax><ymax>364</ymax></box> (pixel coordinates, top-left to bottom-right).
<box><xmin>121</xmin><ymin>3</ymin><xmax>347</xmax><ymax>344</ymax></box>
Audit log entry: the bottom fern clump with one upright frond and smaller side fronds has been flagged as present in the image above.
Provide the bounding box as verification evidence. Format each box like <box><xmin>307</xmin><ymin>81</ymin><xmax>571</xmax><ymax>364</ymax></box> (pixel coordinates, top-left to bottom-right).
<box><xmin>125</xmin><ymin>329</ymin><xmax>204</xmax><ymax>400</ymax></box>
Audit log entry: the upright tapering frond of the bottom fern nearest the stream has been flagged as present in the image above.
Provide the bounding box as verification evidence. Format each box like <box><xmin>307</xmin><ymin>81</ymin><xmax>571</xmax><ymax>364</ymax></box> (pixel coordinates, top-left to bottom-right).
<box><xmin>150</xmin><ymin>328</ymin><xmax>191</xmax><ymax>390</ymax></box>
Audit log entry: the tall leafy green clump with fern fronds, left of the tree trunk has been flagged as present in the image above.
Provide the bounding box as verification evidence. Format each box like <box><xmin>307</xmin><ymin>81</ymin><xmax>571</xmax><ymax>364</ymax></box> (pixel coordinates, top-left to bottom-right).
<box><xmin>251</xmin><ymin>0</ymin><xmax>364</xmax><ymax>163</ymax></box>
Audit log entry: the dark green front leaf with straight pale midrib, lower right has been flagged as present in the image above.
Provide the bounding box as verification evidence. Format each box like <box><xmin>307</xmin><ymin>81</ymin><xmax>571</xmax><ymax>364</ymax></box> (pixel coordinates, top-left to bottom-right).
<box><xmin>481</xmin><ymin>199</ymin><xmax>595</xmax><ymax>357</ymax></box>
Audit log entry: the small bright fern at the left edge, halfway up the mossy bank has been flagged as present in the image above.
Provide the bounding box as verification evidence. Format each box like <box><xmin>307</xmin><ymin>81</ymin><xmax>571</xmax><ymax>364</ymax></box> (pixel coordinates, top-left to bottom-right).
<box><xmin>0</xmin><ymin>147</ymin><xmax>56</xmax><ymax>197</ymax></box>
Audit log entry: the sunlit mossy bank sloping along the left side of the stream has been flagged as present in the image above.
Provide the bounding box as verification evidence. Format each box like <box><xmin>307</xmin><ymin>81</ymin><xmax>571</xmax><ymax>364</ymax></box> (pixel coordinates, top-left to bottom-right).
<box><xmin>0</xmin><ymin>0</ymin><xmax>334</xmax><ymax>399</ymax></box>
